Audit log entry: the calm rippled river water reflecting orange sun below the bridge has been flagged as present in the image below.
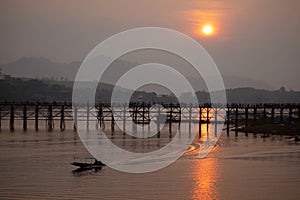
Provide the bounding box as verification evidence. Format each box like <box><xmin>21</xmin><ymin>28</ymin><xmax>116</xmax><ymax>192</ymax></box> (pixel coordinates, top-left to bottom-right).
<box><xmin>0</xmin><ymin>124</ymin><xmax>300</xmax><ymax>199</ymax></box>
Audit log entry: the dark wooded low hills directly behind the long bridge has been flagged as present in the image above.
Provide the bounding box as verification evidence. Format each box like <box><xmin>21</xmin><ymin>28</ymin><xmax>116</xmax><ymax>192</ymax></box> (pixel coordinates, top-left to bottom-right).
<box><xmin>0</xmin><ymin>78</ymin><xmax>300</xmax><ymax>104</ymax></box>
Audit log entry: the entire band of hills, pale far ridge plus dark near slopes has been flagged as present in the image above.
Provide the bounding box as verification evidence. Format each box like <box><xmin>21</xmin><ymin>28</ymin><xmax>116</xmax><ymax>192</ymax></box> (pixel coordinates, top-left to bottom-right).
<box><xmin>0</xmin><ymin>57</ymin><xmax>300</xmax><ymax>103</ymax></box>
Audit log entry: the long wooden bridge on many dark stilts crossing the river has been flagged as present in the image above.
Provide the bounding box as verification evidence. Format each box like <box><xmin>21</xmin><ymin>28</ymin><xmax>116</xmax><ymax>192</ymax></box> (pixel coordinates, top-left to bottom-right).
<box><xmin>0</xmin><ymin>102</ymin><xmax>300</xmax><ymax>137</ymax></box>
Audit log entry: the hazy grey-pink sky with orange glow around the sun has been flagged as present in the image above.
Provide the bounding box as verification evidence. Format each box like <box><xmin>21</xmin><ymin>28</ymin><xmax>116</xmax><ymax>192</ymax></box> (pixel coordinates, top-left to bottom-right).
<box><xmin>0</xmin><ymin>0</ymin><xmax>300</xmax><ymax>90</ymax></box>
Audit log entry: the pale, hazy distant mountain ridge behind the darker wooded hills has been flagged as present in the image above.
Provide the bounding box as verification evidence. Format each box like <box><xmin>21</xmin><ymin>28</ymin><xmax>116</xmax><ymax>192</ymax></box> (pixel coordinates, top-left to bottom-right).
<box><xmin>1</xmin><ymin>57</ymin><xmax>278</xmax><ymax>90</ymax></box>
